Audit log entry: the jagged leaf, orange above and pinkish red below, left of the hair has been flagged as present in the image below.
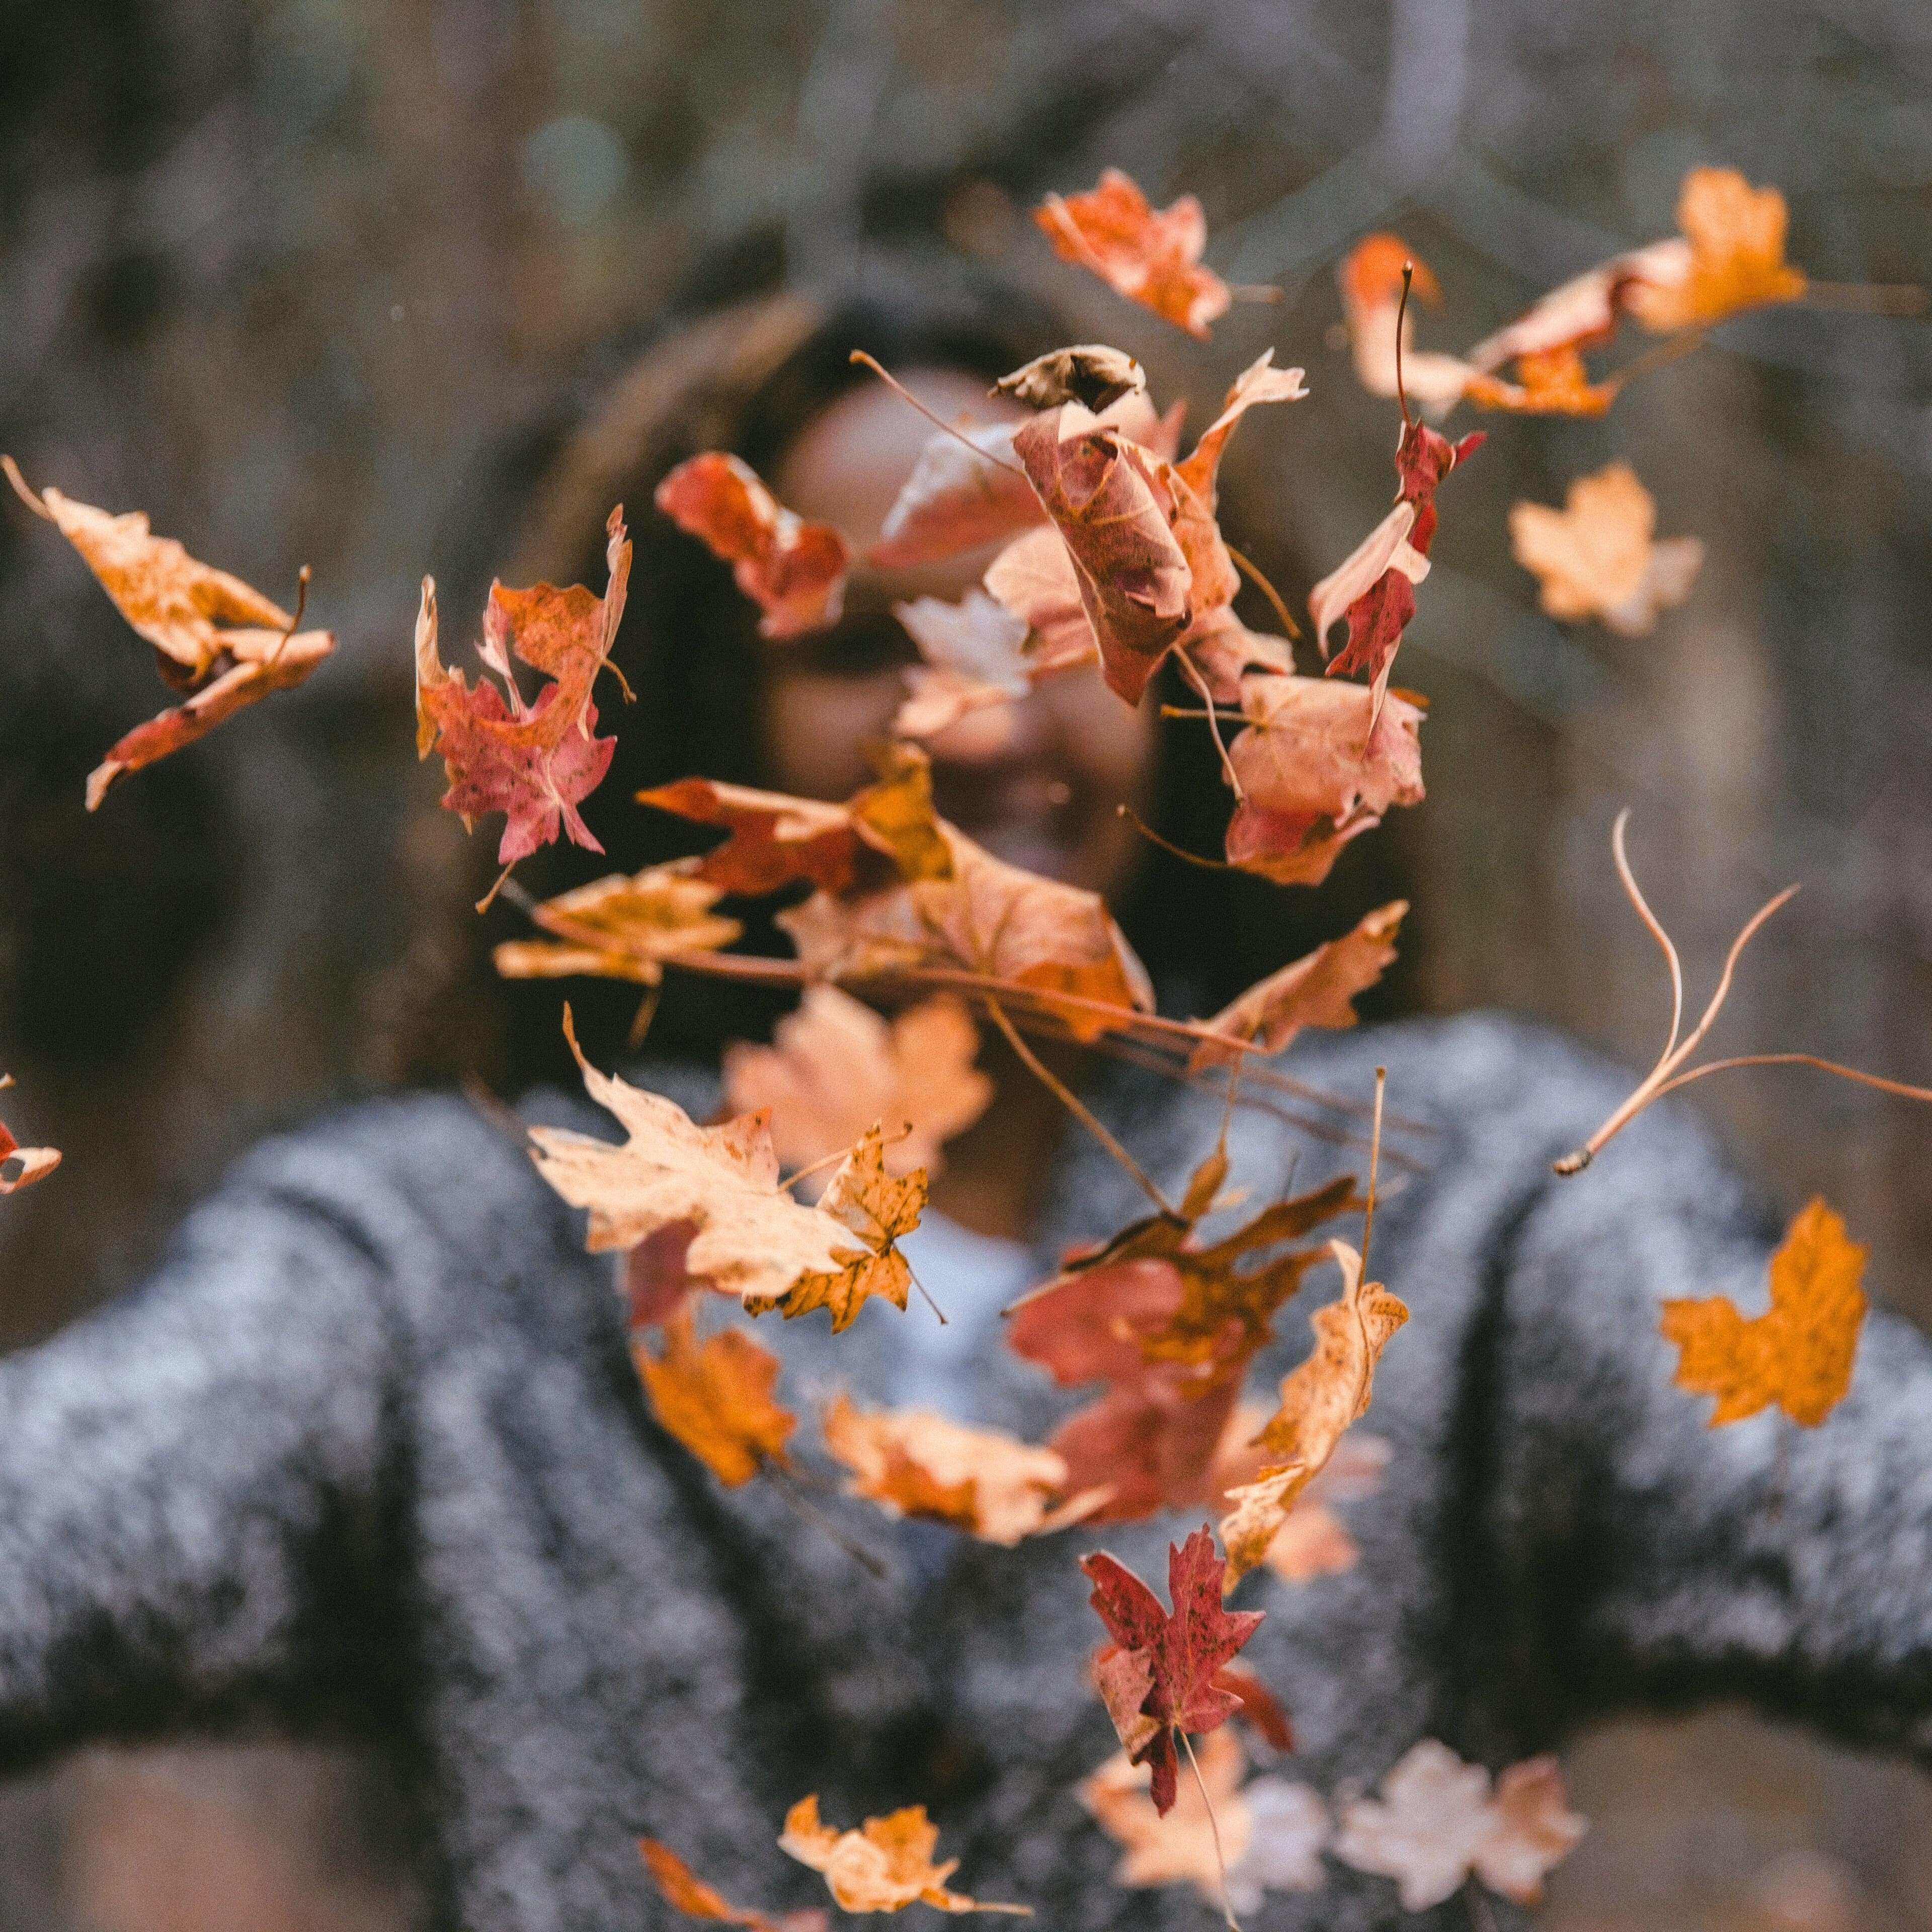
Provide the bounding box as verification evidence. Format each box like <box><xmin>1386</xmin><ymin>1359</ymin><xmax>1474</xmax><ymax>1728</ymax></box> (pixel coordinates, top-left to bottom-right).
<box><xmin>416</xmin><ymin>521</ymin><xmax>630</xmax><ymax>865</ymax></box>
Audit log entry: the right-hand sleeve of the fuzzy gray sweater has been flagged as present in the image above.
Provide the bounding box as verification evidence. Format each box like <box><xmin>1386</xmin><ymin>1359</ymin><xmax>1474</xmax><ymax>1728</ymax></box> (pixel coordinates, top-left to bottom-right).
<box><xmin>1455</xmin><ymin>1109</ymin><xmax>1932</xmax><ymax>1762</ymax></box>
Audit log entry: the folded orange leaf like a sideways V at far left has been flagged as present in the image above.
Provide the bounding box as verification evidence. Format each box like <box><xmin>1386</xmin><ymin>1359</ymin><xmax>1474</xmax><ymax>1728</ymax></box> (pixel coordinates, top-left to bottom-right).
<box><xmin>0</xmin><ymin>456</ymin><xmax>336</xmax><ymax>812</ymax></box>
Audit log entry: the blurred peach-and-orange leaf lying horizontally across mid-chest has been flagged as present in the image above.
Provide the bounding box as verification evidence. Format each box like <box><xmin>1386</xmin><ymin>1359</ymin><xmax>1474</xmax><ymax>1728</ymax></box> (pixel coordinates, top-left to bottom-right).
<box><xmin>825</xmin><ymin>1395</ymin><xmax>1092</xmax><ymax>1550</ymax></box>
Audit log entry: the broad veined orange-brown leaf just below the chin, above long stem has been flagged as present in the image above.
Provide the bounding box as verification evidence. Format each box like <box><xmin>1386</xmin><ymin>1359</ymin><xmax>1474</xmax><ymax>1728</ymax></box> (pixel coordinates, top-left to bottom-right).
<box><xmin>779</xmin><ymin>819</ymin><xmax>1153</xmax><ymax>1039</ymax></box>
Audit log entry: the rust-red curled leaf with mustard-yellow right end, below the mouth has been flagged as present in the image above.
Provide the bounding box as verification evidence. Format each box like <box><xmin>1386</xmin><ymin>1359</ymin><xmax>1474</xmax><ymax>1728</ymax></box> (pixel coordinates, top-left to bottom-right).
<box><xmin>637</xmin><ymin>744</ymin><xmax>952</xmax><ymax>897</ymax></box>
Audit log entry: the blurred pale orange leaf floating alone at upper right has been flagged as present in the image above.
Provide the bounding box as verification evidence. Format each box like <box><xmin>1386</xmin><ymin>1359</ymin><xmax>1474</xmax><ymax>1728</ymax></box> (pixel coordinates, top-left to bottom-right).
<box><xmin>1509</xmin><ymin>464</ymin><xmax>1704</xmax><ymax>637</ymax></box>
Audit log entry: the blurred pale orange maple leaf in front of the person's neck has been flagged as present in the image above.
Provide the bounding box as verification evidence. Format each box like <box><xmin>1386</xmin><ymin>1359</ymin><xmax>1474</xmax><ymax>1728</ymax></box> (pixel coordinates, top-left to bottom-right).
<box><xmin>725</xmin><ymin>985</ymin><xmax>993</xmax><ymax>1175</ymax></box>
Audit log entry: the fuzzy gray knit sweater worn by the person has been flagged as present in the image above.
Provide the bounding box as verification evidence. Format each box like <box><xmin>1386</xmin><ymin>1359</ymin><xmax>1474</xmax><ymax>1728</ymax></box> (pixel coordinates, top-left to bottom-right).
<box><xmin>0</xmin><ymin>1016</ymin><xmax>1932</xmax><ymax>1932</ymax></box>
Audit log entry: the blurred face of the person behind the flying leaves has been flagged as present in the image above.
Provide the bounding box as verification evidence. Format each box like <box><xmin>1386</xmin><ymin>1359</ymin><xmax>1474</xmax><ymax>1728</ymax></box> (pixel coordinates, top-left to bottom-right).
<box><xmin>761</xmin><ymin>369</ymin><xmax>1155</xmax><ymax>895</ymax></box>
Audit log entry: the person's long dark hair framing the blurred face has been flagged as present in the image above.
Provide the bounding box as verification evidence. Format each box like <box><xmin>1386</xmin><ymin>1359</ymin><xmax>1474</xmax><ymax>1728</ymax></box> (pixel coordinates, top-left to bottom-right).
<box><xmin>483</xmin><ymin>257</ymin><xmax>1401</xmax><ymax>1076</ymax></box>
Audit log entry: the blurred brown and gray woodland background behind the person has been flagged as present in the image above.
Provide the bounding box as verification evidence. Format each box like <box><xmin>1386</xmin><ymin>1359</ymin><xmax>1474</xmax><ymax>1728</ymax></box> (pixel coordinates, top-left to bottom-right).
<box><xmin>0</xmin><ymin>0</ymin><xmax>1932</xmax><ymax>1932</ymax></box>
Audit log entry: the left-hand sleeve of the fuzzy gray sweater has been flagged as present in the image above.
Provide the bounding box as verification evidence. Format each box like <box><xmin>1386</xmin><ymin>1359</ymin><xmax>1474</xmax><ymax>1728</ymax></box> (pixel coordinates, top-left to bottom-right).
<box><xmin>0</xmin><ymin>1103</ymin><xmax>533</xmax><ymax>1764</ymax></box>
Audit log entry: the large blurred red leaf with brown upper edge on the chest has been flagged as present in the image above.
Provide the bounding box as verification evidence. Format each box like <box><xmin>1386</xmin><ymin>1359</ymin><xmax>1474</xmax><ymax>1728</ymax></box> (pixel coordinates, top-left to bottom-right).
<box><xmin>1007</xmin><ymin>1153</ymin><xmax>1354</xmax><ymax>1522</ymax></box>
